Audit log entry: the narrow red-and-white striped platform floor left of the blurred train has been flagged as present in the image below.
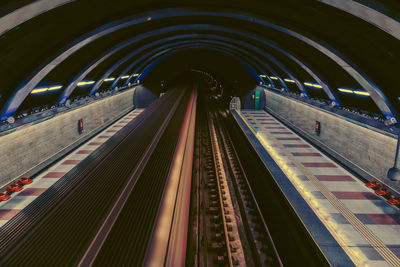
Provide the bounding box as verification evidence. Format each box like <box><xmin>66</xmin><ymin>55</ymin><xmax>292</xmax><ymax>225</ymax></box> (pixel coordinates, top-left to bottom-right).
<box><xmin>0</xmin><ymin>109</ymin><xmax>143</xmax><ymax>227</ymax></box>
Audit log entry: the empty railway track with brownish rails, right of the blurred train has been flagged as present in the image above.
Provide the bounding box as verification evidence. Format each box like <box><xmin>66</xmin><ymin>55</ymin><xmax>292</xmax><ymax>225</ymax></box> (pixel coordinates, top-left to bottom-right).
<box><xmin>187</xmin><ymin>93</ymin><xmax>282</xmax><ymax>266</ymax></box>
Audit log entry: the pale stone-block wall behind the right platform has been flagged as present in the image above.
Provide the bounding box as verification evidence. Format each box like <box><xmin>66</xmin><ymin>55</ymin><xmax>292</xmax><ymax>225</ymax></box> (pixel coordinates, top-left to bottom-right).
<box><xmin>266</xmin><ymin>90</ymin><xmax>398</xmax><ymax>187</ymax></box>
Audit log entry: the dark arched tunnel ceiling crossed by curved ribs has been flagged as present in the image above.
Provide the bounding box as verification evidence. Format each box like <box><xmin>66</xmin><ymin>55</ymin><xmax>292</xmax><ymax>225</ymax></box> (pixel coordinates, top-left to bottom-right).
<box><xmin>0</xmin><ymin>0</ymin><xmax>400</xmax><ymax>119</ymax></box>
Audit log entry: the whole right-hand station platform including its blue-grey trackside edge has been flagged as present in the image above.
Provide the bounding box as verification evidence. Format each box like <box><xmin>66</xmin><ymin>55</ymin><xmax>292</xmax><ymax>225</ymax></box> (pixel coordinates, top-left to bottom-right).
<box><xmin>232</xmin><ymin>110</ymin><xmax>400</xmax><ymax>266</ymax></box>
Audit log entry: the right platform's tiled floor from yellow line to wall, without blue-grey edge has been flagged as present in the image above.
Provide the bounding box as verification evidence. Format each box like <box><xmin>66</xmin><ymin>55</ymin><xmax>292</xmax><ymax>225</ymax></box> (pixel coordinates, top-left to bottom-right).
<box><xmin>238</xmin><ymin>110</ymin><xmax>400</xmax><ymax>266</ymax></box>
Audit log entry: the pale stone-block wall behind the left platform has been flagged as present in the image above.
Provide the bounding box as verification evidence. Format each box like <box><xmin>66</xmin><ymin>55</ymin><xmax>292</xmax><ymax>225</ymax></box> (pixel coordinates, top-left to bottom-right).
<box><xmin>0</xmin><ymin>89</ymin><xmax>135</xmax><ymax>186</ymax></box>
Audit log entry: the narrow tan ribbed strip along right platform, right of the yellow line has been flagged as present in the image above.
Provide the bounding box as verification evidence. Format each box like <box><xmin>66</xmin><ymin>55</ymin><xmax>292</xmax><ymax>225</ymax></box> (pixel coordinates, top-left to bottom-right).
<box><xmin>238</xmin><ymin>112</ymin><xmax>400</xmax><ymax>266</ymax></box>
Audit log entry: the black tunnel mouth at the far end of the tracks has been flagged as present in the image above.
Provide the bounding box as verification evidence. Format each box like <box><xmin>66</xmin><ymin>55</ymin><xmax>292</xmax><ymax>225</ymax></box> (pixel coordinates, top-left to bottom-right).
<box><xmin>143</xmin><ymin>49</ymin><xmax>259</xmax><ymax>108</ymax></box>
